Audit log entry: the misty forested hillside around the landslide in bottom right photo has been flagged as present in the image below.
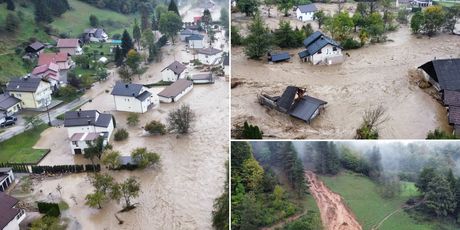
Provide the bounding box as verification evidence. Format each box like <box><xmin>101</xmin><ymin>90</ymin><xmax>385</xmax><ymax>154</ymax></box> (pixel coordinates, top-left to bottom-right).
<box><xmin>231</xmin><ymin>141</ymin><xmax>460</xmax><ymax>229</ymax></box>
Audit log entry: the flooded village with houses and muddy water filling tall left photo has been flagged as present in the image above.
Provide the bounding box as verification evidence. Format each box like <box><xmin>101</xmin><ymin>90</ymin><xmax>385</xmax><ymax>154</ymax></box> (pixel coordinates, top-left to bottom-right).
<box><xmin>0</xmin><ymin>0</ymin><xmax>230</xmax><ymax>229</ymax></box>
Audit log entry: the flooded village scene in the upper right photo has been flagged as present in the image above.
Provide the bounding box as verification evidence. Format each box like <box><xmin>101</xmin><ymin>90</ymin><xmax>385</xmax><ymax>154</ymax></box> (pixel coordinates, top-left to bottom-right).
<box><xmin>231</xmin><ymin>1</ymin><xmax>460</xmax><ymax>139</ymax></box>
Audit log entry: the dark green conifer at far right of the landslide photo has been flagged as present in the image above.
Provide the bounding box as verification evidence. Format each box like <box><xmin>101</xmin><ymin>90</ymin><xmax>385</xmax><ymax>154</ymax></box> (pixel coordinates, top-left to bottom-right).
<box><xmin>425</xmin><ymin>175</ymin><xmax>457</xmax><ymax>216</ymax></box>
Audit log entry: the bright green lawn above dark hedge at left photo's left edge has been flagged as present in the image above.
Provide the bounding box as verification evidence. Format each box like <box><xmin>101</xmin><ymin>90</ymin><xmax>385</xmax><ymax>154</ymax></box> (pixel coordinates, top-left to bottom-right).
<box><xmin>0</xmin><ymin>124</ymin><xmax>48</xmax><ymax>163</ymax></box>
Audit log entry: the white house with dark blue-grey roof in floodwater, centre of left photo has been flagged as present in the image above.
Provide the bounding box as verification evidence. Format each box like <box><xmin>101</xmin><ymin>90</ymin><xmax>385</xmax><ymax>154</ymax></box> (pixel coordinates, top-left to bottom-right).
<box><xmin>112</xmin><ymin>81</ymin><xmax>160</xmax><ymax>113</ymax></box>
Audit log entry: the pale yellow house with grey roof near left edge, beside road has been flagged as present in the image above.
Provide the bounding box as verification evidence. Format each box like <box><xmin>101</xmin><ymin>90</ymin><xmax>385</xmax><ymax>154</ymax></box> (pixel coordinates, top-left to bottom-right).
<box><xmin>6</xmin><ymin>77</ymin><xmax>52</xmax><ymax>109</ymax></box>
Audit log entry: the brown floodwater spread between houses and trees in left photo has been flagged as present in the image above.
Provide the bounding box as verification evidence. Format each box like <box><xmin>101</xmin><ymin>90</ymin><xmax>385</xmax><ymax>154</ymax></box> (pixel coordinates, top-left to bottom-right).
<box><xmin>22</xmin><ymin>4</ymin><xmax>230</xmax><ymax>230</ymax></box>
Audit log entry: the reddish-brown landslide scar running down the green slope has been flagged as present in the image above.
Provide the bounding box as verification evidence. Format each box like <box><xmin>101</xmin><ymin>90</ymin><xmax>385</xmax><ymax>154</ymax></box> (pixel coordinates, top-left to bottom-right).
<box><xmin>305</xmin><ymin>171</ymin><xmax>362</xmax><ymax>230</ymax></box>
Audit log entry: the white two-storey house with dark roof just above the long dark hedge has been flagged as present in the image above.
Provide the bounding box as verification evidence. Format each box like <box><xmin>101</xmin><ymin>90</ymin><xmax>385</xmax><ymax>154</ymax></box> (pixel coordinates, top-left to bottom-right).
<box><xmin>64</xmin><ymin>110</ymin><xmax>116</xmax><ymax>154</ymax></box>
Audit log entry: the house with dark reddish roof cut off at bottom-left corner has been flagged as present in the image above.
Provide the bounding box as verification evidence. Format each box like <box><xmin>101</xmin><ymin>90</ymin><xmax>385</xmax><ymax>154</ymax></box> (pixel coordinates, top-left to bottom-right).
<box><xmin>0</xmin><ymin>192</ymin><xmax>26</xmax><ymax>230</ymax></box>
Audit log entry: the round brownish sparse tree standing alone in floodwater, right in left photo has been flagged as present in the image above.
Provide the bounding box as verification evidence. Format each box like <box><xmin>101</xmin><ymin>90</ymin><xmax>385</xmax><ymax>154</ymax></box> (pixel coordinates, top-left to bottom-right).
<box><xmin>168</xmin><ymin>104</ymin><xmax>195</xmax><ymax>134</ymax></box>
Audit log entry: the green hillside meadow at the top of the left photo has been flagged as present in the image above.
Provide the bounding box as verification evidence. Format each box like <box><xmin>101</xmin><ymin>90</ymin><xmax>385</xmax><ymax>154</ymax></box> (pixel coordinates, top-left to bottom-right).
<box><xmin>51</xmin><ymin>0</ymin><xmax>134</xmax><ymax>37</ymax></box>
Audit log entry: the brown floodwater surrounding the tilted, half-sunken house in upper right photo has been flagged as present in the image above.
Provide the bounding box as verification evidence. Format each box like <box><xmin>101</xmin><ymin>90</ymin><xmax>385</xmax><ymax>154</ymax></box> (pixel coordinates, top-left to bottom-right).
<box><xmin>231</xmin><ymin>12</ymin><xmax>460</xmax><ymax>139</ymax></box>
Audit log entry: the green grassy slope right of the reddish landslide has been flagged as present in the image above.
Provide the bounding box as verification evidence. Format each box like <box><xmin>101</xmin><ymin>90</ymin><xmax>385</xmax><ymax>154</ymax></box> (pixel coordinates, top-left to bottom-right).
<box><xmin>321</xmin><ymin>172</ymin><xmax>438</xmax><ymax>230</ymax></box>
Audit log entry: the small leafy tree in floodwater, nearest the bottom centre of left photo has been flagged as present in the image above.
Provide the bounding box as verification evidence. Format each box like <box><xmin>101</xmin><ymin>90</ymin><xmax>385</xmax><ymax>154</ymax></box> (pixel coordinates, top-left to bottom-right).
<box><xmin>111</xmin><ymin>177</ymin><xmax>141</xmax><ymax>209</ymax></box>
